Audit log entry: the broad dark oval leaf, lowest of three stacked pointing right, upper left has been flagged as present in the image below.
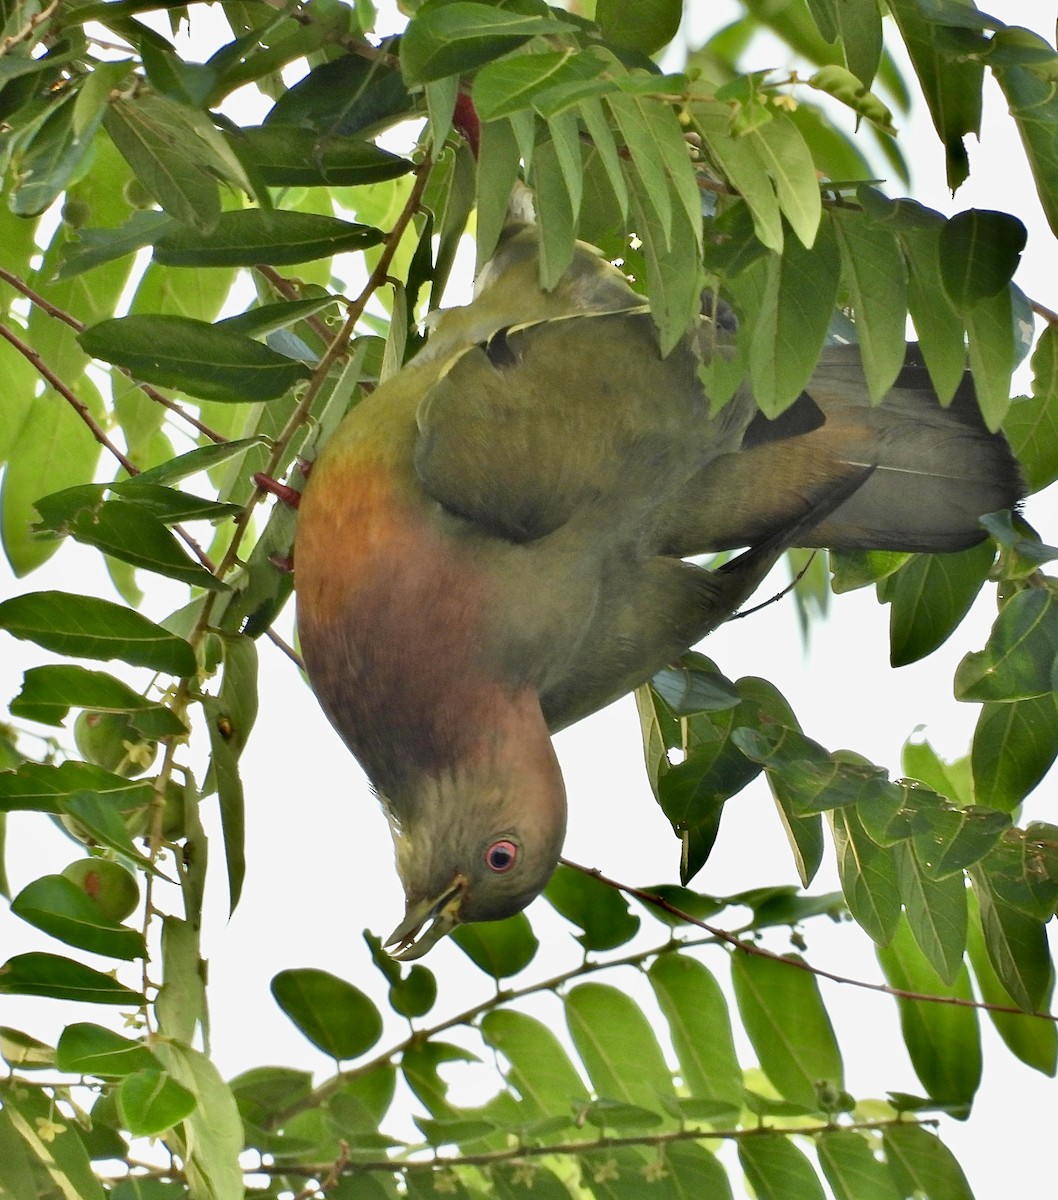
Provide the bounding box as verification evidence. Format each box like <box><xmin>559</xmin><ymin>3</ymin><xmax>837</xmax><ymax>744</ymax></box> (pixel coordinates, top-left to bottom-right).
<box><xmin>79</xmin><ymin>316</ymin><xmax>312</xmax><ymax>403</ymax></box>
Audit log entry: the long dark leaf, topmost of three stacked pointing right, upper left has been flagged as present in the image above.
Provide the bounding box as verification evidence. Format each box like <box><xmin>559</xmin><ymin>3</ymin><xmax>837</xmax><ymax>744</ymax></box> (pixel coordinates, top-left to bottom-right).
<box><xmin>221</xmin><ymin>121</ymin><xmax>415</xmax><ymax>187</ymax></box>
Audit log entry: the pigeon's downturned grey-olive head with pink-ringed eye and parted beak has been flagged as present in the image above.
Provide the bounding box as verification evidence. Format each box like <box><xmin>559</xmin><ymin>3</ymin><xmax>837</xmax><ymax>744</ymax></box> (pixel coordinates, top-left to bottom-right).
<box><xmin>385</xmin><ymin>691</ymin><xmax>566</xmax><ymax>961</ymax></box>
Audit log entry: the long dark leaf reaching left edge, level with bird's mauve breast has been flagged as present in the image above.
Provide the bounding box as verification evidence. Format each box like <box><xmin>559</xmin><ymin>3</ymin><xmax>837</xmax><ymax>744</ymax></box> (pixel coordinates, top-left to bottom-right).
<box><xmin>0</xmin><ymin>592</ymin><xmax>196</xmax><ymax>676</ymax></box>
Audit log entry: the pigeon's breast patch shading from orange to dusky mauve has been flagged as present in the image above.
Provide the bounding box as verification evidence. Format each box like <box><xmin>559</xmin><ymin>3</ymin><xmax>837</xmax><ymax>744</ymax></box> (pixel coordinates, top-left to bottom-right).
<box><xmin>295</xmin><ymin>454</ymin><xmax>497</xmax><ymax>791</ymax></box>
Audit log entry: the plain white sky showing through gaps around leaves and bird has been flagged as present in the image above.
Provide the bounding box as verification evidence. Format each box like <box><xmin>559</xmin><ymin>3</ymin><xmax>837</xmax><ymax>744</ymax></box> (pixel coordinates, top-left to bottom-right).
<box><xmin>0</xmin><ymin>0</ymin><xmax>1058</xmax><ymax>1200</ymax></box>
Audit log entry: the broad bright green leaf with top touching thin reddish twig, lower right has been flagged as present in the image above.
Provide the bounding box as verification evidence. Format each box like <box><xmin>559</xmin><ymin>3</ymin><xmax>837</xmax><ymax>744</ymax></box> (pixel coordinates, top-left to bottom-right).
<box><xmin>732</xmin><ymin>953</ymin><xmax>844</xmax><ymax>1111</ymax></box>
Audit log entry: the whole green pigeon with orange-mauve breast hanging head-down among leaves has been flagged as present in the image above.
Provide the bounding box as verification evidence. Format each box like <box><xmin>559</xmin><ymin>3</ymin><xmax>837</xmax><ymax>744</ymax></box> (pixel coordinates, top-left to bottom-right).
<box><xmin>294</xmin><ymin>224</ymin><xmax>1023</xmax><ymax>961</ymax></box>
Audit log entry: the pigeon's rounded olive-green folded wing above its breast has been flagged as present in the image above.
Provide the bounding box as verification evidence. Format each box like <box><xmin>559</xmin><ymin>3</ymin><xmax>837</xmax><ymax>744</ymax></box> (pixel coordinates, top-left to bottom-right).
<box><xmin>415</xmin><ymin>311</ymin><xmax>749</xmax><ymax>541</ymax></box>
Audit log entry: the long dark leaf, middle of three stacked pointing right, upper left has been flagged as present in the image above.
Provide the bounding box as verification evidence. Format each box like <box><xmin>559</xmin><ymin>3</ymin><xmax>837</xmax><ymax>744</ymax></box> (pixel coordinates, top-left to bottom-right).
<box><xmin>155</xmin><ymin>209</ymin><xmax>383</xmax><ymax>266</ymax></box>
